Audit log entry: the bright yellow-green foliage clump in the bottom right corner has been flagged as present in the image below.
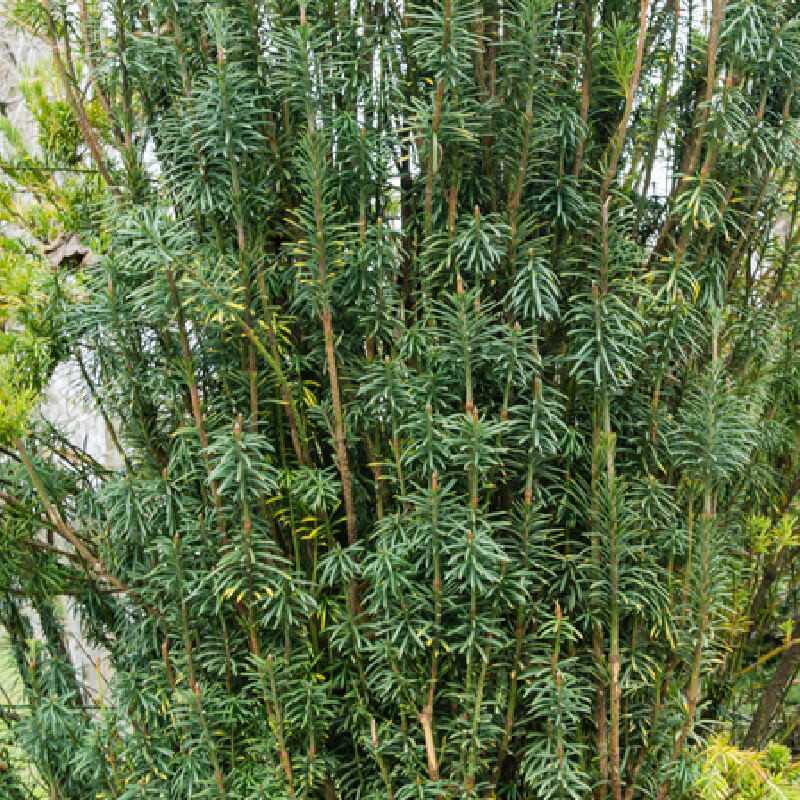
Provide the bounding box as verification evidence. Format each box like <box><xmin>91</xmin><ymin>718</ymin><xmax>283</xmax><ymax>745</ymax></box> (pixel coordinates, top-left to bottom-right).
<box><xmin>696</xmin><ymin>736</ymin><xmax>800</xmax><ymax>800</ymax></box>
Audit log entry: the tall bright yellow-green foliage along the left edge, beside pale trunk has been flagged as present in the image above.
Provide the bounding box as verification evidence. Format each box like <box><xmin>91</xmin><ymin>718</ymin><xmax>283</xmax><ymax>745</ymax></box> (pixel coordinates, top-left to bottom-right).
<box><xmin>0</xmin><ymin>62</ymin><xmax>107</xmax><ymax>443</ymax></box>
